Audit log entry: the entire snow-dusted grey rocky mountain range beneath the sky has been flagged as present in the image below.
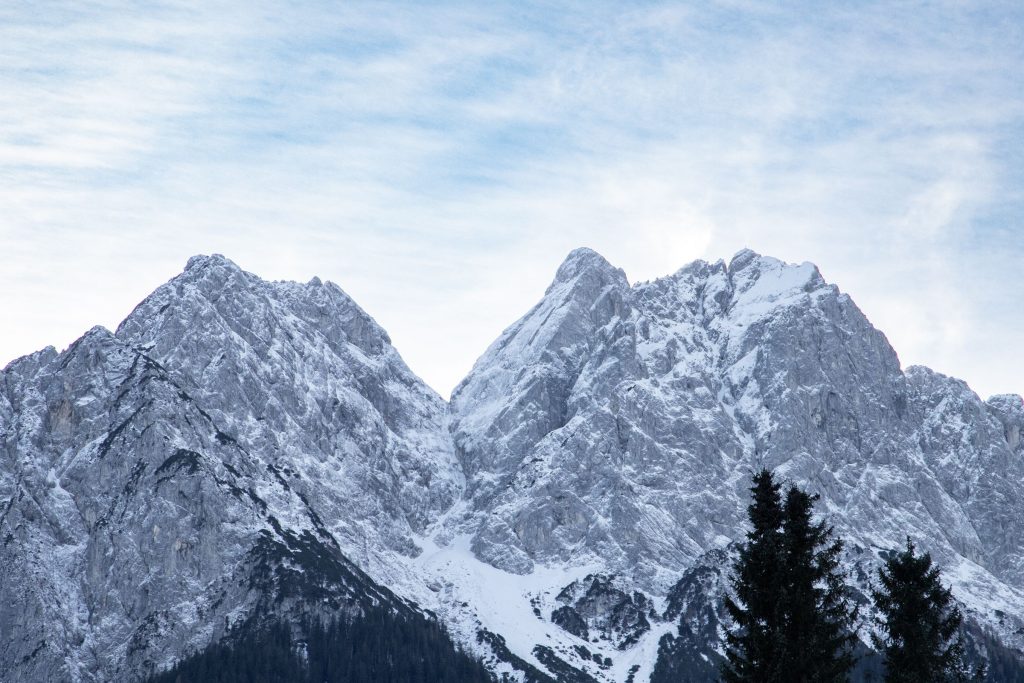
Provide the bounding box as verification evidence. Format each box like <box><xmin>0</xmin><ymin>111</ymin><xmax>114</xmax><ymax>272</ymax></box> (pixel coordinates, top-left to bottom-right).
<box><xmin>0</xmin><ymin>249</ymin><xmax>1024</xmax><ymax>683</ymax></box>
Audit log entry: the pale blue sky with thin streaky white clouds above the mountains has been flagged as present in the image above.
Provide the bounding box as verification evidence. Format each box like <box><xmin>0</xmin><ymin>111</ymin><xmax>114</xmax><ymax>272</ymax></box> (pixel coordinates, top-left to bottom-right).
<box><xmin>0</xmin><ymin>0</ymin><xmax>1024</xmax><ymax>396</ymax></box>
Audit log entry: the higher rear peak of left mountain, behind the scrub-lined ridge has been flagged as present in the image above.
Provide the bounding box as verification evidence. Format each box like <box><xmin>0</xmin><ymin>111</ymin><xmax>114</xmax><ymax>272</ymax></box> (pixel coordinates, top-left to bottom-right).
<box><xmin>117</xmin><ymin>256</ymin><xmax>463</xmax><ymax>561</ymax></box>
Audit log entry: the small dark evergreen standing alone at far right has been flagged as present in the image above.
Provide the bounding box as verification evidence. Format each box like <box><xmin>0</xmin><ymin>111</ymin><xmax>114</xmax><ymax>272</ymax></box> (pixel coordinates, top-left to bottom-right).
<box><xmin>871</xmin><ymin>538</ymin><xmax>966</xmax><ymax>683</ymax></box>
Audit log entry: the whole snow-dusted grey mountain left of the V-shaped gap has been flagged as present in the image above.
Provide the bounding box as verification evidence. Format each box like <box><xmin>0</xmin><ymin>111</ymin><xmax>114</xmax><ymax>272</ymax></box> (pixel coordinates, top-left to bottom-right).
<box><xmin>0</xmin><ymin>257</ymin><xmax>462</xmax><ymax>681</ymax></box>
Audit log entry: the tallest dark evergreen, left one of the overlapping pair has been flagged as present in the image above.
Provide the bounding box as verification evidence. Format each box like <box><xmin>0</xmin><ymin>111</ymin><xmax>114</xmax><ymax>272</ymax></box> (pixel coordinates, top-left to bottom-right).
<box><xmin>722</xmin><ymin>469</ymin><xmax>785</xmax><ymax>683</ymax></box>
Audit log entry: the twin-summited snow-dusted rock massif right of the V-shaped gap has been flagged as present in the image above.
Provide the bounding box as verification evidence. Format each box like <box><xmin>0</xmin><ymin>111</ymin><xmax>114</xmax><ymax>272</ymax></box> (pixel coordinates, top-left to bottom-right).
<box><xmin>452</xmin><ymin>251</ymin><xmax>899</xmax><ymax>590</ymax></box>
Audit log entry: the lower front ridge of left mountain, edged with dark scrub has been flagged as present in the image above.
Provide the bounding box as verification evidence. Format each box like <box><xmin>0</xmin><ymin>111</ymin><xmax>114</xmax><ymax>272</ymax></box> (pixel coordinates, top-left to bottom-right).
<box><xmin>0</xmin><ymin>328</ymin><xmax>393</xmax><ymax>681</ymax></box>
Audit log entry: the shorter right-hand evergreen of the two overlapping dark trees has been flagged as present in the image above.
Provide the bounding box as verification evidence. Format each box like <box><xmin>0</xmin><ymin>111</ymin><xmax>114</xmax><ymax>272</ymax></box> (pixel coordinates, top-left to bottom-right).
<box><xmin>781</xmin><ymin>486</ymin><xmax>857</xmax><ymax>683</ymax></box>
